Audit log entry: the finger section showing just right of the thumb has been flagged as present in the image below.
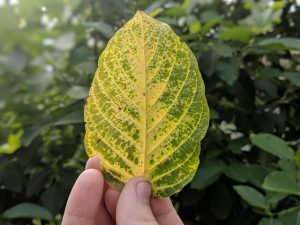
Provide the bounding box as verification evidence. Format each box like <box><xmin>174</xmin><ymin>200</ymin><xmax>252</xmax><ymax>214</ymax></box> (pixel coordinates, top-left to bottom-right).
<box><xmin>150</xmin><ymin>198</ymin><xmax>183</xmax><ymax>225</ymax></box>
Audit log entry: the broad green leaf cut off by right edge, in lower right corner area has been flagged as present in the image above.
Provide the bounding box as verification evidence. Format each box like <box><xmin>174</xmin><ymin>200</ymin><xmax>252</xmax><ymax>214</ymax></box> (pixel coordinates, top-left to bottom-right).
<box><xmin>263</xmin><ymin>171</ymin><xmax>300</xmax><ymax>195</ymax></box>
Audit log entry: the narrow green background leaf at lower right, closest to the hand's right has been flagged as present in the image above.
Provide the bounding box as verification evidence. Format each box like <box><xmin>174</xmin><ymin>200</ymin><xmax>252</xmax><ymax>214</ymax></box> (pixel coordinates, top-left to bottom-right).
<box><xmin>233</xmin><ymin>185</ymin><xmax>269</xmax><ymax>209</ymax></box>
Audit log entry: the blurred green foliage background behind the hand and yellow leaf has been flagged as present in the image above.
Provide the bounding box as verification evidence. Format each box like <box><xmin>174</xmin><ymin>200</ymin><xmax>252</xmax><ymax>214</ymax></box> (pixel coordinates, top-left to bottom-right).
<box><xmin>0</xmin><ymin>0</ymin><xmax>300</xmax><ymax>225</ymax></box>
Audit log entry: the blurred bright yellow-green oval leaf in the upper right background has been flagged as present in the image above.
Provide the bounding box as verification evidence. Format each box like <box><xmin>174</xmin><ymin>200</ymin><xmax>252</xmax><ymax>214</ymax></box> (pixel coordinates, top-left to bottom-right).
<box><xmin>220</xmin><ymin>27</ymin><xmax>252</xmax><ymax>43</ymax></box>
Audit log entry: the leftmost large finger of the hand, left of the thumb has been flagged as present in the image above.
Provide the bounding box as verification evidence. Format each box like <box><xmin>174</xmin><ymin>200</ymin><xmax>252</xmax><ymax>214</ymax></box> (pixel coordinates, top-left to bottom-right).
<box><xmin>62</xmin><ymin>169</ymin><xmax>104</xmax><ymax>225</ymax></box>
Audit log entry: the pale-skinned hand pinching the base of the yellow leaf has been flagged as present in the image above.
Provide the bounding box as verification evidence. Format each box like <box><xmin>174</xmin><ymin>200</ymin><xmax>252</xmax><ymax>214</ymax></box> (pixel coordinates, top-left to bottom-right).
<box><xmin>62</xmin><ymin>157</ymin><xmax>183</xmax><ymax>225</ymax></box>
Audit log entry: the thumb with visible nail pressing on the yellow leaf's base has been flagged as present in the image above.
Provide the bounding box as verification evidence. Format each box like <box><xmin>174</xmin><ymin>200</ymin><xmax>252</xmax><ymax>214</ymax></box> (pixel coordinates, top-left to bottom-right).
<box><xmin>116</xmin><ymin>177</ymin><xmax>158</xmax><ymax>225</ymax></box>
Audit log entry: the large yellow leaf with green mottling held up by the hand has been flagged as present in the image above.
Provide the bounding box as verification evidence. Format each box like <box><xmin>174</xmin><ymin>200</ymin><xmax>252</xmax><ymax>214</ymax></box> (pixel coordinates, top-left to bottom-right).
<box><xmin>84</xmin><ymin>11</ymin><xmax>209</xmax><ymax>197</ymax></box>
